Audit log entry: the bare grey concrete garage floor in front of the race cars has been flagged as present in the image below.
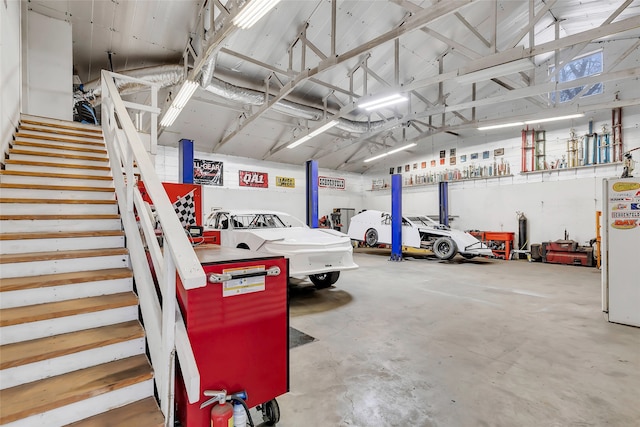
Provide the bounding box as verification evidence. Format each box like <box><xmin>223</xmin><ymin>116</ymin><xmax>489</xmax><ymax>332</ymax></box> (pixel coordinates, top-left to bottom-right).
<box><xmin>252</xmin><ymin>253</ymin><xmax>640</xmax><ymax>427</ymax></box>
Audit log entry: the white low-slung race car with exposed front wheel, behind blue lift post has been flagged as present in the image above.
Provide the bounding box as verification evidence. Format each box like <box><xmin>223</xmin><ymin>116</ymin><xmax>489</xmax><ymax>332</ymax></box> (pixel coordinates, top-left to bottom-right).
<box><xmin>348</xmin><ymin>210</ymin><xmax>493</xmax><ymax>260</ymax></box>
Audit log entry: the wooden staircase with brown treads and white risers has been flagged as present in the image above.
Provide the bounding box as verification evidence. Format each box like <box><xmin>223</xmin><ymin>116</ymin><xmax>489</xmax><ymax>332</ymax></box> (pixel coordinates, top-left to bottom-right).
<box><xmin>0</xmin><ymin>115</ymin><xmax>164</xmax><ymax>426</ymax></box>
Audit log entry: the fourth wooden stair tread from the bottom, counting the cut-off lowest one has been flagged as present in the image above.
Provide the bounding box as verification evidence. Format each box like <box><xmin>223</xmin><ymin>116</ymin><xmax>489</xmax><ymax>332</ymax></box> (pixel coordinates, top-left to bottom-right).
<box><xmin>0</xmin><ymin>292</ymin><xmax>138</xmax><ymax>328</ymax></box>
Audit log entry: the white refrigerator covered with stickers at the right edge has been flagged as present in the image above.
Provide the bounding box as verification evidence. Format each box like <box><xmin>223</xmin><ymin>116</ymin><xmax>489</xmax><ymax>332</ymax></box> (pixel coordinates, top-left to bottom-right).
<box><xmin>602</xmin><ymin>178</ymin><xmax>640</xmax><ymax>326</ymax></box>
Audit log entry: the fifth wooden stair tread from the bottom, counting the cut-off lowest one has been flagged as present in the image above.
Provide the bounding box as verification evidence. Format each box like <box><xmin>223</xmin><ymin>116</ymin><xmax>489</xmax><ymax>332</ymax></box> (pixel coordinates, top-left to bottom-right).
<box><xmin>0</xmin><ymin>268</ymin><xmax>133</xmax><ymax>292</ymax></box>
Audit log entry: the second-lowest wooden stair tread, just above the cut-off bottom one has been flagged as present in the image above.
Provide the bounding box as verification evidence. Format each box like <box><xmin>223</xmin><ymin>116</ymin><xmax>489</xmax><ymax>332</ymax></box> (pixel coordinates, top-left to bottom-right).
<box><xmin>0</xmin><ymin>355</ymin><xmax>153</xmax><ymax>424</ymax></box>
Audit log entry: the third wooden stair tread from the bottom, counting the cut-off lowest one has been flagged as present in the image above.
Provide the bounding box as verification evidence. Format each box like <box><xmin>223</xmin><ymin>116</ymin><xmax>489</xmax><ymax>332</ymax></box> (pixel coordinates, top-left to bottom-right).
<box><xmin>0</xmin><ymin>320</ymin><xmax>144</xmax><ymax>369</ymax></box>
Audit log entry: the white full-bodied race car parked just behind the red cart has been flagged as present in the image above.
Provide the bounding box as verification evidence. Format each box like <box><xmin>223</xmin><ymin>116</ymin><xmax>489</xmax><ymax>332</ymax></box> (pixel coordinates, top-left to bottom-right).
<box><xmin>204</xmin><ymin>210</ymin><xmax>358</xmax><ymax>289</ymax></box>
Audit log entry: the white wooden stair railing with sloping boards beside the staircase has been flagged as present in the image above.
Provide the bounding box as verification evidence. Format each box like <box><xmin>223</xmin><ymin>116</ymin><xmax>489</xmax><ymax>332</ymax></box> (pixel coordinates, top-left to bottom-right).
<box><xmin>102</xmin><ymin>70</ymin><xmax>207</xmax><ymax>426</ymax></box>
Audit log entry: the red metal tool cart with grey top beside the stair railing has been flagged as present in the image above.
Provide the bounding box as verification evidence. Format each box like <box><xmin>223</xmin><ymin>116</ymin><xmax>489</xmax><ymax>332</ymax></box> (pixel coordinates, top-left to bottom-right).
<box><xmin>176</xmin><ymin>245</ymin><xmax>289</xmax><ymax>427</ymax></box>
